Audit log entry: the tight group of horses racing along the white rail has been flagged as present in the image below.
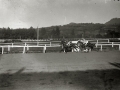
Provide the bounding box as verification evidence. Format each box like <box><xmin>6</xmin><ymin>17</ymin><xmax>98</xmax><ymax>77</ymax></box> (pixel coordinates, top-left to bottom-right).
<box><xmin>60</xmin><ymin>40</ymin><xmax>95</xmax><ymax>53</ymax></box>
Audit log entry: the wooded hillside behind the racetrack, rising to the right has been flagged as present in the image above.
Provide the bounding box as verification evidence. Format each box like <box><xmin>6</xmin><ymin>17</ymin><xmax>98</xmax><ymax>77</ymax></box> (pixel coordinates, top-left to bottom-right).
<box><xmin>40</xmin><ymin>18</ymin><xmax>120</xmax><ymax>38</ymax></box>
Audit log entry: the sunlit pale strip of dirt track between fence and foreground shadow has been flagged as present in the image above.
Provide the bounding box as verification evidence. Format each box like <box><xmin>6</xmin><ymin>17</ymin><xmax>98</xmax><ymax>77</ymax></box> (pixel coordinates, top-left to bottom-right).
<box><xmin>0</xmin><ymin>51</ymin><xmax>120</xmax><ymax>73</ymax></box>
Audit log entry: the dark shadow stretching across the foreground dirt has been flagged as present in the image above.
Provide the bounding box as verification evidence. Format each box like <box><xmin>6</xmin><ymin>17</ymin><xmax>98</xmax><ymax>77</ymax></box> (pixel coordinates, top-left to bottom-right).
<box><xmin>0</xmin><ymin>68</ymin><xmax>120</xmax><ymax>90</ymax></box>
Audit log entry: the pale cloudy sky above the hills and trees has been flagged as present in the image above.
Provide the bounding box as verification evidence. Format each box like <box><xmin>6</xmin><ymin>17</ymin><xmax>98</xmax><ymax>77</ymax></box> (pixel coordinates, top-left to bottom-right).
<box><xmin>0</xmin><ymin>0</ymin><xmax>120</xmax><ymax>29</ymax></box>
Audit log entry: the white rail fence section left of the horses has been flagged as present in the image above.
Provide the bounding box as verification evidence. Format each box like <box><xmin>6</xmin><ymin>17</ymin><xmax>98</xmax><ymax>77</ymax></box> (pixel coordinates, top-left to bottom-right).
<box><xmin>0</xmin><ymin>42</ymin><xmax>61</xmax><ymax>54</ymax></box>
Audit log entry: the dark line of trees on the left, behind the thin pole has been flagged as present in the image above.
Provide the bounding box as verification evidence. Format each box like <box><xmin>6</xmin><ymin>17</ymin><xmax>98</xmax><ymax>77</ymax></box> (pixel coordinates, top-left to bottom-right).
<box><xmin>0</xmin><ymin>26</ymin><xmax>60</xmax><ymax>39</ymax></box>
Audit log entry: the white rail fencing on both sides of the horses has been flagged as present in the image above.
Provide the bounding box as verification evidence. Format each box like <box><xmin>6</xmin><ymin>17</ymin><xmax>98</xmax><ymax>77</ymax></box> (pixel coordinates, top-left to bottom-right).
<box><xmin>0</xmin><ymin>39</ymin><xmax>120</xmax><ymax>54</ymax></box>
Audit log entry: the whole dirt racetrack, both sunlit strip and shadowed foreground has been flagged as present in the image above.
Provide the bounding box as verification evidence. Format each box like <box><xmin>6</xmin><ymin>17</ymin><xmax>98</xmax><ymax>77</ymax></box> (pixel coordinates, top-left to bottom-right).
<box><xmin>0</xmin><ymin>51</ymin><xmax>120</xmax><ymax>90</ymax></box>
